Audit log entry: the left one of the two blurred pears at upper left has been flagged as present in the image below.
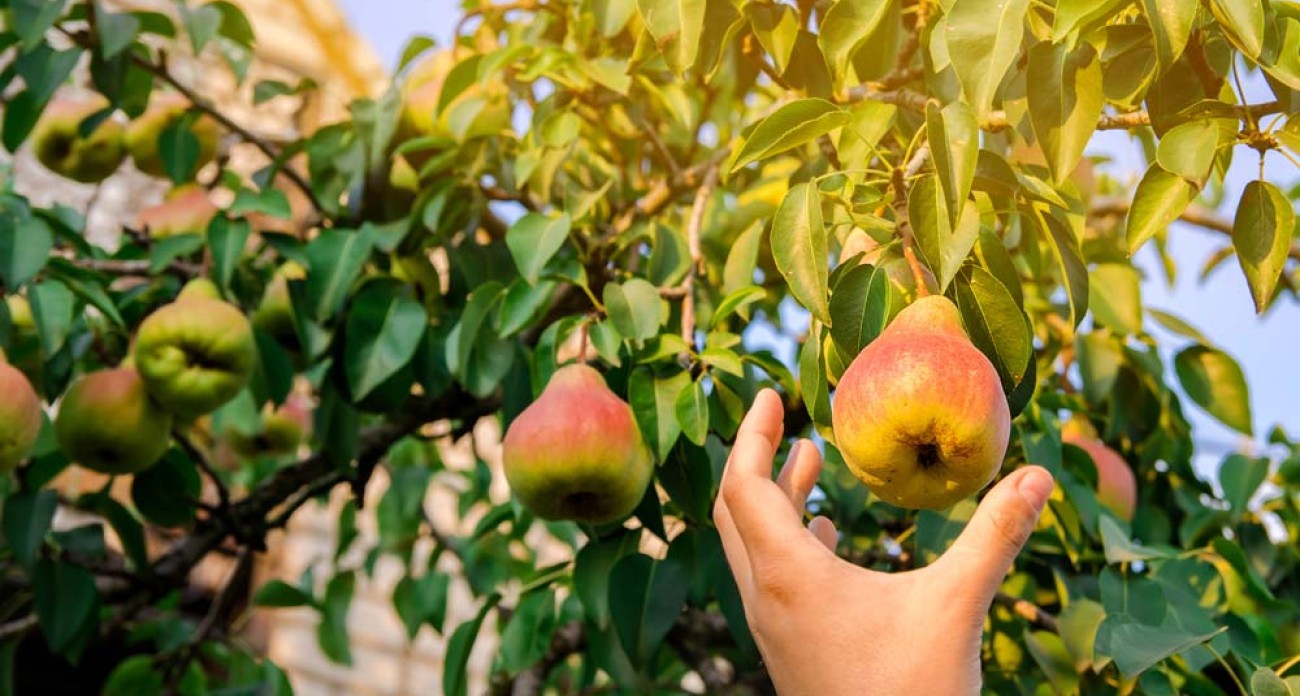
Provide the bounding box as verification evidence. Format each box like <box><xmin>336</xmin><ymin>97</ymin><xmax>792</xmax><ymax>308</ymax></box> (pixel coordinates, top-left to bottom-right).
<box><xmin>31</xmin><ymin>98</ymin><xmax>126</xmax><ymax>183</ymax></box>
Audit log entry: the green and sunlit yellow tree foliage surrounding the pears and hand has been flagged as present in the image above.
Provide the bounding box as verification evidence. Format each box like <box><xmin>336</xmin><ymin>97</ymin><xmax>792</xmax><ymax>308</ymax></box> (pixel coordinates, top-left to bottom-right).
<box><xmin>0</xmin><ymin>0</ymin><xmax>1300</xmax><ymax>695</ymax></box>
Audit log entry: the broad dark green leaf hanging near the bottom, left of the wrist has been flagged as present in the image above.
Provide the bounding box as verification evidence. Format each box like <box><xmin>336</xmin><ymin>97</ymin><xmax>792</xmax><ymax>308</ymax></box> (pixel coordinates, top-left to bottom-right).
<box><xmin>610</xmin><ymin>553</ymin><xmax>690</xmax><ymax>665</ymax></box>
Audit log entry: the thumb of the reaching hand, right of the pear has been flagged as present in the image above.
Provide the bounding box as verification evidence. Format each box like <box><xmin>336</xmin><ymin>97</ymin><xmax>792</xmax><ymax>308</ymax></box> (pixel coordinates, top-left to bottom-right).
<box><xmin>936</xmin><ymin>466</ymin><xmax>1053</xmax><ymax>604</ymax></box>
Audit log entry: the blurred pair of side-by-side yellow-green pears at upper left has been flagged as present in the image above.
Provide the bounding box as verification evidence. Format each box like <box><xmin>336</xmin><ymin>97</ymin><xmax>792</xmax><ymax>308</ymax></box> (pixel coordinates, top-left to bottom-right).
<box><xmin>31</xmin><ymin>92</ymin><xmax>221</xmax><ymax>183</ymax></box>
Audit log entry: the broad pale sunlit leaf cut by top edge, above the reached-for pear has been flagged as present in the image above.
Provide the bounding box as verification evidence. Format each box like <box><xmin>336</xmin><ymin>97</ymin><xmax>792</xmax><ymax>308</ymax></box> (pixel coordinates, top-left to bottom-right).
<box><xmin>944</xmin><ymin>0</ymin><xmax>1030</xmax><ymax>118</ymax></box>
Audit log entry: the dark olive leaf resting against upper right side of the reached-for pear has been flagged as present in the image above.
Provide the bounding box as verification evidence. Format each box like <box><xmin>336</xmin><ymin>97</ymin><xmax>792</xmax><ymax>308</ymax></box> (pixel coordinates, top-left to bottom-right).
<box><xmin>953</xmin><ymin>265</ymin><xmax>1034</xmax><ymax>394</ymax></box>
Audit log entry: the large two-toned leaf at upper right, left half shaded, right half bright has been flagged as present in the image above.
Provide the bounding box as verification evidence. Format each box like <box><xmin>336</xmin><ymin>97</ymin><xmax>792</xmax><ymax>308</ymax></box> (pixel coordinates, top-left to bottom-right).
<box><xmin>1024</xmin><ymin>42</ymin><xmax>1105</xmax><ymax>186</ymax></box>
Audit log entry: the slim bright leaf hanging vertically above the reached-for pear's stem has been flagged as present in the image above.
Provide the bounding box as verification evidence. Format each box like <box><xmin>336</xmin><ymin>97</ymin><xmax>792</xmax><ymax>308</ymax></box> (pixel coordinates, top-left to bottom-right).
<box><xmin>925</xmin><ymin>101</ymin><xmax>979</xmax><ymax>223</ymax></box>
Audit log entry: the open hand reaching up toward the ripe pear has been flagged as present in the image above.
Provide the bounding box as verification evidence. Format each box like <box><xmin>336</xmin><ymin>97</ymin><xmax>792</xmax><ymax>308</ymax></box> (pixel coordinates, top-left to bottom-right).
<box><xmin>714</xmin><ymin>390</ymin><xmax>1053</xmax><ymax>696</ymax></box>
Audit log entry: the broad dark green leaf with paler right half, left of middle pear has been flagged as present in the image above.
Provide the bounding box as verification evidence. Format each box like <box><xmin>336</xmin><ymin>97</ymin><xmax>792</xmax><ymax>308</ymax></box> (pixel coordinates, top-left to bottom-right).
<box><xmin>343</xmin><ymin>278</ymin><xmax>429</xmax><ymax>401</ymax></box>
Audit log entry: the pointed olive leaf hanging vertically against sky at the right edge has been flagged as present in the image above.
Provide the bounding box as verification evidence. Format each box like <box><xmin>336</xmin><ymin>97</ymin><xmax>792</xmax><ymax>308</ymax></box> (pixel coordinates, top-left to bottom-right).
<box><xmin>1232</xmin><ymin>181</ymin><xmax>1296</xmax><ymax>314</ymax></box>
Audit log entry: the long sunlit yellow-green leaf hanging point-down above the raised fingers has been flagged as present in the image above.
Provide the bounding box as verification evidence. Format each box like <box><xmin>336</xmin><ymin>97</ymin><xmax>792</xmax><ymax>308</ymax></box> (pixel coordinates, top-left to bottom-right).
<box><xmin>772</xmin><ymin>183</ymin><xmax>831</xmax><ymax>325</ymax></box>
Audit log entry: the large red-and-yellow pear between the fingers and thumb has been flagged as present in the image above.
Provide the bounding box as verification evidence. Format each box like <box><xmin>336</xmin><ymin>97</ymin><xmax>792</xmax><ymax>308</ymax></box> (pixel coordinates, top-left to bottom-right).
<box><xmin>831</xmin><ymin>295</ymin><xmax>1011</xmax><ymax>510</ymax></box>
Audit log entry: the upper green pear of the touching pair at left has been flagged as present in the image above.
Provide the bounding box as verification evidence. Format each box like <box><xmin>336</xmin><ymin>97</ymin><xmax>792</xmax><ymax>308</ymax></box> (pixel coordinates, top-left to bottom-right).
<box><xmin>134</xmin><ymin>297</ymin><xmax>257</xmax><ymax>418</ymax></box>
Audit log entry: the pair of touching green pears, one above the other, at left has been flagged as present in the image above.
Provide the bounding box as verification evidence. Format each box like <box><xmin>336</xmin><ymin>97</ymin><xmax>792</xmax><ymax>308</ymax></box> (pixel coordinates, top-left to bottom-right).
<box><xmin>55</xmin><ymin>278</ymin><xmax>257</xmax><ymax>475</ymax></box>
